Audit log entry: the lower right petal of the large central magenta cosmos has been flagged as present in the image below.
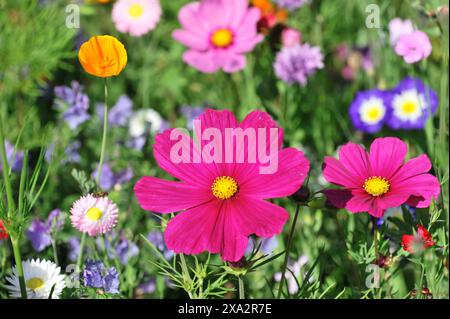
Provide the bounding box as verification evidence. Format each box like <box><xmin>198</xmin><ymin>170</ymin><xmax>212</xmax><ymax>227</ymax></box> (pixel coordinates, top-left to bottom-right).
<box><xmin>230</xmin><ymin>195</ymin><xmax>289</xmax><ymax>238</ymax></box>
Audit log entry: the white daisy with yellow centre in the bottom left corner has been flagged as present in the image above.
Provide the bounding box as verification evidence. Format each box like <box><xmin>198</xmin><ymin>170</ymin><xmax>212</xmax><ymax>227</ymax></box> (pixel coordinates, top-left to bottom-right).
<box><xmin>5</xmin><ymin>259</ymin><xmax>66</xmax><ymax>299</ymax></box>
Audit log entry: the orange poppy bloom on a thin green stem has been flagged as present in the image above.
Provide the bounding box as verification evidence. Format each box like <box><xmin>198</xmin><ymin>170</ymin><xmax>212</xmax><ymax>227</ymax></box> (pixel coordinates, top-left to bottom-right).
<box><xmin>78</xmin><ymin>35</ymin><xmax>127</xmax><ymax>78</ymax></box>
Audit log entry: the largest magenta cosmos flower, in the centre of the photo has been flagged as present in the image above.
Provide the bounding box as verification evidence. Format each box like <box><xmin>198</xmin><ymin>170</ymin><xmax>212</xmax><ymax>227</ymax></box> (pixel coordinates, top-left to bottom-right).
<box><xmin>134</xmin><ymin>109</ymin><xmax>309</xmax><ymax>261</ymax></box>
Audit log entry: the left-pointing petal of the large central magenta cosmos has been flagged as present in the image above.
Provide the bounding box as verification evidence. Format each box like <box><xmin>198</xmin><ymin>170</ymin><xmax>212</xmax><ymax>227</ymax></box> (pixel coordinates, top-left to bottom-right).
<box><xmin>134</xmin><ymin>176</ymin><xmax>213</xmax><ymax>213</ymax></box>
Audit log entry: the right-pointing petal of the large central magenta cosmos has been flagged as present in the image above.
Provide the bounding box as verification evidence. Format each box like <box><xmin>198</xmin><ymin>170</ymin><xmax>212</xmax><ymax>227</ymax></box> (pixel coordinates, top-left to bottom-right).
<box><xmin>236</xmin><ymin>148</ymin><xmax>309</xmax><ymax>199</ymax></box>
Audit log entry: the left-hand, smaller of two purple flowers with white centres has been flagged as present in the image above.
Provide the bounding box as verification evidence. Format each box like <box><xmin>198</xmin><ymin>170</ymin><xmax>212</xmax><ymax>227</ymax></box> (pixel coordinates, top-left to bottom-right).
<box><xmin>349</xmin><ymin>90</ymin><xmax>389</xmax><ymax>133</ymax></box>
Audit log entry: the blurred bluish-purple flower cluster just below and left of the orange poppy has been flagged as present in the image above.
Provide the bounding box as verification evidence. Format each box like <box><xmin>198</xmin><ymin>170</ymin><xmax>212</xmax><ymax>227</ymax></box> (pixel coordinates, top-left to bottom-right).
<box><xmin>55</xmin><ymin>81</ymin><xmax>90</xmax><ymax>130</ymax></box>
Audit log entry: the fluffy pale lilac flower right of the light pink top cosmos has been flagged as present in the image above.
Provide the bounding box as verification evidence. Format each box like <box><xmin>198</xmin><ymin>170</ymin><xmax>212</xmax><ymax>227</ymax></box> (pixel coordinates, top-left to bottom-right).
<box><xmin>274</xmin><ymin>43</ymin><xmax>323</xmax><ymax>86</ymax></box>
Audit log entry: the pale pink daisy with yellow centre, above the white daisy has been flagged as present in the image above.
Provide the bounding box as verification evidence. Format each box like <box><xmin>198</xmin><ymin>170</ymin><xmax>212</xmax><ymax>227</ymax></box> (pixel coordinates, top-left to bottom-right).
<box><xmin>70</xmin><ymin>194</ymin><xmax>119</xmax><ymax>236</ymax></box>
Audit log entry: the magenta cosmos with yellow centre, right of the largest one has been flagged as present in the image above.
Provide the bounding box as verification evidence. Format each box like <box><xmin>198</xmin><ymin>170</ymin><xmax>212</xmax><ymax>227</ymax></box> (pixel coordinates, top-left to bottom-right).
<box><xmin>323</xmin><ymin>137</ymin><xmax>440</xmax><ymax>218</ymax></box>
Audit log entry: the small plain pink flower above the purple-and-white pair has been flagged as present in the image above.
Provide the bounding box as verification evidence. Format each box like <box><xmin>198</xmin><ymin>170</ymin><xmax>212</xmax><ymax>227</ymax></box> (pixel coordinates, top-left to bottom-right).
<box><xmin>395</xmin><ymin>31</ymin><xmax>432</xmax><ymax>64</ymax></box>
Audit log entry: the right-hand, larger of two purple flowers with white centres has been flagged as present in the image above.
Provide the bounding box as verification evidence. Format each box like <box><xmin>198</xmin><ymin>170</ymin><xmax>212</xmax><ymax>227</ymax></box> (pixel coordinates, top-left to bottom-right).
<box><xmin>386</xmin><ymin>77</ymin><xmax>439</xmax><ymax>130</ymax></box>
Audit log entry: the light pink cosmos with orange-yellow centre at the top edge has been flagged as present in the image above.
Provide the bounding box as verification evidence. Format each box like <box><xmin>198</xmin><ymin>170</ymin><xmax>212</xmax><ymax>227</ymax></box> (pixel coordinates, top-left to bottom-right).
<box><xmin>173</xmin><ymin>0</ymin><xmax>263</xmax><ymax>73</ymax></box>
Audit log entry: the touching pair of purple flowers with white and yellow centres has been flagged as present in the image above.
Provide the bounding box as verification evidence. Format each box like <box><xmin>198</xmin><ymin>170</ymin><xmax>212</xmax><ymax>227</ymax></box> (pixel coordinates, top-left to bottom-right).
<box><xmin>349</xmin><ymin>77</ymin><xmax>439</xmax><ymax>133</ymax></box>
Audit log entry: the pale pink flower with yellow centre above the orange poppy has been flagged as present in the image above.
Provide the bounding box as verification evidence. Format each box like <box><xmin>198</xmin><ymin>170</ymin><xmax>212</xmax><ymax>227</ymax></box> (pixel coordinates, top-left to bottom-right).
<box><xmin>112</xmin><ymin>0</ymin><xmax>161</xmax><ymax>37</ymax></box>
